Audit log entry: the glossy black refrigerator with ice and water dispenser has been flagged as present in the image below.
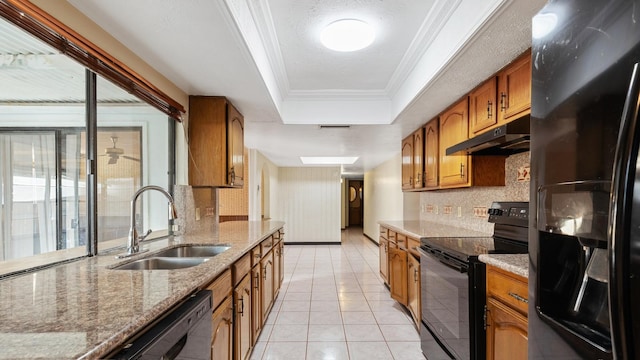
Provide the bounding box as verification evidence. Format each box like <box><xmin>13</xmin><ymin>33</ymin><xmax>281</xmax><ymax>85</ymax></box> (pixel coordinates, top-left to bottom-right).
<box><xmin>528</xmin><ymin>0</ymin><xmax>640</xmax><ymax>359</ymax></box>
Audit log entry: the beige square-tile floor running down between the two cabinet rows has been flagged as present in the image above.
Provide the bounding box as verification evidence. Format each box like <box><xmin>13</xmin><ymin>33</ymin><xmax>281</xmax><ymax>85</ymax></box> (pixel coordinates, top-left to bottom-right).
<box><xmin>251</xmin><ymin>228</ymin><xmax>424</xmax><ymax>360</ymax></box>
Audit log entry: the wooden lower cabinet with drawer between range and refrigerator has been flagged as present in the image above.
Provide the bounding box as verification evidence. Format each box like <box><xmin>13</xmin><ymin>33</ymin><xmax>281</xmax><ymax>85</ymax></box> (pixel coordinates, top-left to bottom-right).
<box><xmin>486</xmin><ymin>265</ymin><xmax>528</xmax><ymax>360</ymax></box>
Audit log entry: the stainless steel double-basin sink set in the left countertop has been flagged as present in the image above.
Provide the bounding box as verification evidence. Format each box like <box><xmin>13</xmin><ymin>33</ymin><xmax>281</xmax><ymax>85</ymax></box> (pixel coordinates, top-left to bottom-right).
<box><xmin>112</xmin><ymin>245</ymin><xmax>231</xmax><ymax>270</ymax></box>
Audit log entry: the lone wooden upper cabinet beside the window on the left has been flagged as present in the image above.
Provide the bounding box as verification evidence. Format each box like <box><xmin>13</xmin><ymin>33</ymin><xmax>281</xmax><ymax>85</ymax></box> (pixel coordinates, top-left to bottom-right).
<box><xmin>189</xmin><ymin>96</ymin><xmax>244</xmax><ymax>187</ymax></box>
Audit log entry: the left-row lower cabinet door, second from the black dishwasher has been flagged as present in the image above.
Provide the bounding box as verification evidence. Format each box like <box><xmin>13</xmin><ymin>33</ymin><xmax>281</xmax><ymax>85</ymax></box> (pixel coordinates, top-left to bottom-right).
<box><xmin>233</xmin><ymin>274</ymin><xmax>252</xmax><ymax>360</ymax></box>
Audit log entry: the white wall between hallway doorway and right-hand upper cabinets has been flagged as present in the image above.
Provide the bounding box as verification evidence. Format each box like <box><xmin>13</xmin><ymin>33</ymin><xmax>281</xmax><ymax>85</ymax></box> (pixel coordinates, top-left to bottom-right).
<box><xmin>363</xmin><ymin>153</ymin><xmax>404</xmax><ymax>242</ymax></box>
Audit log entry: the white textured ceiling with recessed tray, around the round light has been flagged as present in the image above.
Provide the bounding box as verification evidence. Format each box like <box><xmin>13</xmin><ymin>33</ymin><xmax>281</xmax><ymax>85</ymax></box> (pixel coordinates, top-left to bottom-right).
<box><xmin>36</xmin><ymin>0</ymin><xmax>545</xmax><ymax>174</ymax></box>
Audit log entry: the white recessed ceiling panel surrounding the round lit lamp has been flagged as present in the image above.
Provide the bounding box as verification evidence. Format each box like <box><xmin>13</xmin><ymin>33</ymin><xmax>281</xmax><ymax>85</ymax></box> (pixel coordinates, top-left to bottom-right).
<box><xmin>269</xmin><ymin>0</ymin><xmax>433</xmax><ymax>91</ymax></box>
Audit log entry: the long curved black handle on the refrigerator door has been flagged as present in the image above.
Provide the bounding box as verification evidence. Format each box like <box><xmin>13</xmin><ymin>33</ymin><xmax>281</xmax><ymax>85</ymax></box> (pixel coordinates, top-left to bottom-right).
<box><xmin>607</xmin><ymin>63</ymin><xmax>640</xmax><ymax>359</ymax></box>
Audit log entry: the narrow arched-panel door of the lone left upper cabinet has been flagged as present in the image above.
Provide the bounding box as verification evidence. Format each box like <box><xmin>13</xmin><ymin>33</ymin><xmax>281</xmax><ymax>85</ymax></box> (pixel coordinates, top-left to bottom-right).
<box><xmin>227</xmin><ymin>104</ymin><xmax>244</xmax><ymax>187</ymax></box>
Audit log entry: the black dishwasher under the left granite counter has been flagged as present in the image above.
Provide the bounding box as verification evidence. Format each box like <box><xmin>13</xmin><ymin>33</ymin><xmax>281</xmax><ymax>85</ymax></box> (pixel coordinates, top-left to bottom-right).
<box><xmin>107</xmin><ymin>290</ymin><xmax>212</xmax><ymax>360</ymax></box>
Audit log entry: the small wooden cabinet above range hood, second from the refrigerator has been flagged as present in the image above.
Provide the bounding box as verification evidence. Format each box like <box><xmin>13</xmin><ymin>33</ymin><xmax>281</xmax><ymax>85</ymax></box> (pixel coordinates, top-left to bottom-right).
<box><xmin>469</xmin><ymin>77</ymin><xmax>498</xmax><ymax>138</ymax></box>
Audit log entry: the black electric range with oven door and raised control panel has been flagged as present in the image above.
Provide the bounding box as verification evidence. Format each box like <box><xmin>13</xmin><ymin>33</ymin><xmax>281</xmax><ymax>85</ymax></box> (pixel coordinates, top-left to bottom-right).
<box><xmin>420</xmin><ymin>202</ymin><xmax>529</xmax><ymax>360</ymax></box>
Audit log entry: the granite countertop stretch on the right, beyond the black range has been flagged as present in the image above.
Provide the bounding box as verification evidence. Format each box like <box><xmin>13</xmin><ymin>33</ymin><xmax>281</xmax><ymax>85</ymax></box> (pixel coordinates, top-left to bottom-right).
<box><xmin>379</xmin><ymin>221</ymin><xmax>491</xmax><ymax>238</ymax></box>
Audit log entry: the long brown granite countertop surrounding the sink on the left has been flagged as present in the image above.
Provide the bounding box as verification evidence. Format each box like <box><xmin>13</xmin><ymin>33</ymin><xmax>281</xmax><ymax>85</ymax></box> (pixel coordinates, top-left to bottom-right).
<box><xmin>0</xmin><ymin>221</ymin><xmax>284</xmax><ymax>359</ymax></box>
